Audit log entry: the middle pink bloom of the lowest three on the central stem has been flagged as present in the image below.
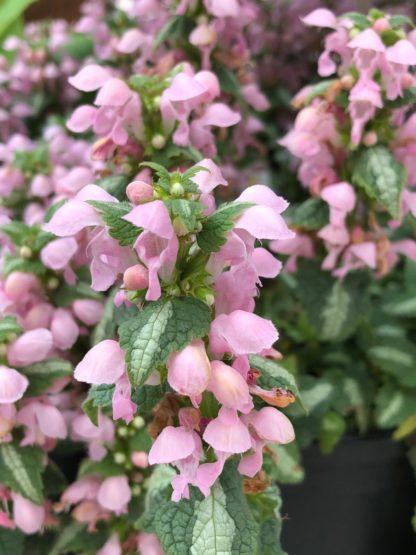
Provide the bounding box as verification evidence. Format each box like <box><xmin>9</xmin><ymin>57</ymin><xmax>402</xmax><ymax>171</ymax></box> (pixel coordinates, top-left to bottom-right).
<box><xmin>203</xmin><ymin>407</ymin><xmax>251</xmax><ymax>454</ymax></box>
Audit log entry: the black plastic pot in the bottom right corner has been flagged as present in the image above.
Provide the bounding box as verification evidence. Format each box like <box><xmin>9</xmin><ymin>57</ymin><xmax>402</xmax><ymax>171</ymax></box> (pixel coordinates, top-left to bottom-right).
<box><xmin>282</xmin><ymin>437</ymin><xmax>416</xmax><ymax>555</ymax></box>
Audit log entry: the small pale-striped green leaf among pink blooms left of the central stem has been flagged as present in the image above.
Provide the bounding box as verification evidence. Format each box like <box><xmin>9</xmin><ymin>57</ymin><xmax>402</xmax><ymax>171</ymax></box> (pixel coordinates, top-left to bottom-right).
<box><xmin>19</xmin><ymin>358</ymin><xmax>73</xmax><ymax>397</ymax></box>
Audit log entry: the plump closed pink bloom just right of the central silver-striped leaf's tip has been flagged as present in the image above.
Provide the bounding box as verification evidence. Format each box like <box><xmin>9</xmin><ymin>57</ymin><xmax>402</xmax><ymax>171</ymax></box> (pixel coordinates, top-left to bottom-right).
<box><xmin>166</xmin><ymin>339</ymin><xmax>211</xmax><ymax>404</ymax></box>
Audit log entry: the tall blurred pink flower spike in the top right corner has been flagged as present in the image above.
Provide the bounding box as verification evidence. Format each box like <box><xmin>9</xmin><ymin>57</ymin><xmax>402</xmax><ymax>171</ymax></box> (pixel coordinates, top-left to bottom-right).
<box><xmin>272</xmin><ymin>9</ymin><xmax>416</xmax><ymax>277</ymax></box>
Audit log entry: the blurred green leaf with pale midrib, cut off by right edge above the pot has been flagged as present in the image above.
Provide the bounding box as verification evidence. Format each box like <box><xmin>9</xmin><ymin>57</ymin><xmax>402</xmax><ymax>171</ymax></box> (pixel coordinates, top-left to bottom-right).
<box><xmin>367</xmin><ymin>338</ymin><xmax>416</xmax><ymax>386</ymax></box>
